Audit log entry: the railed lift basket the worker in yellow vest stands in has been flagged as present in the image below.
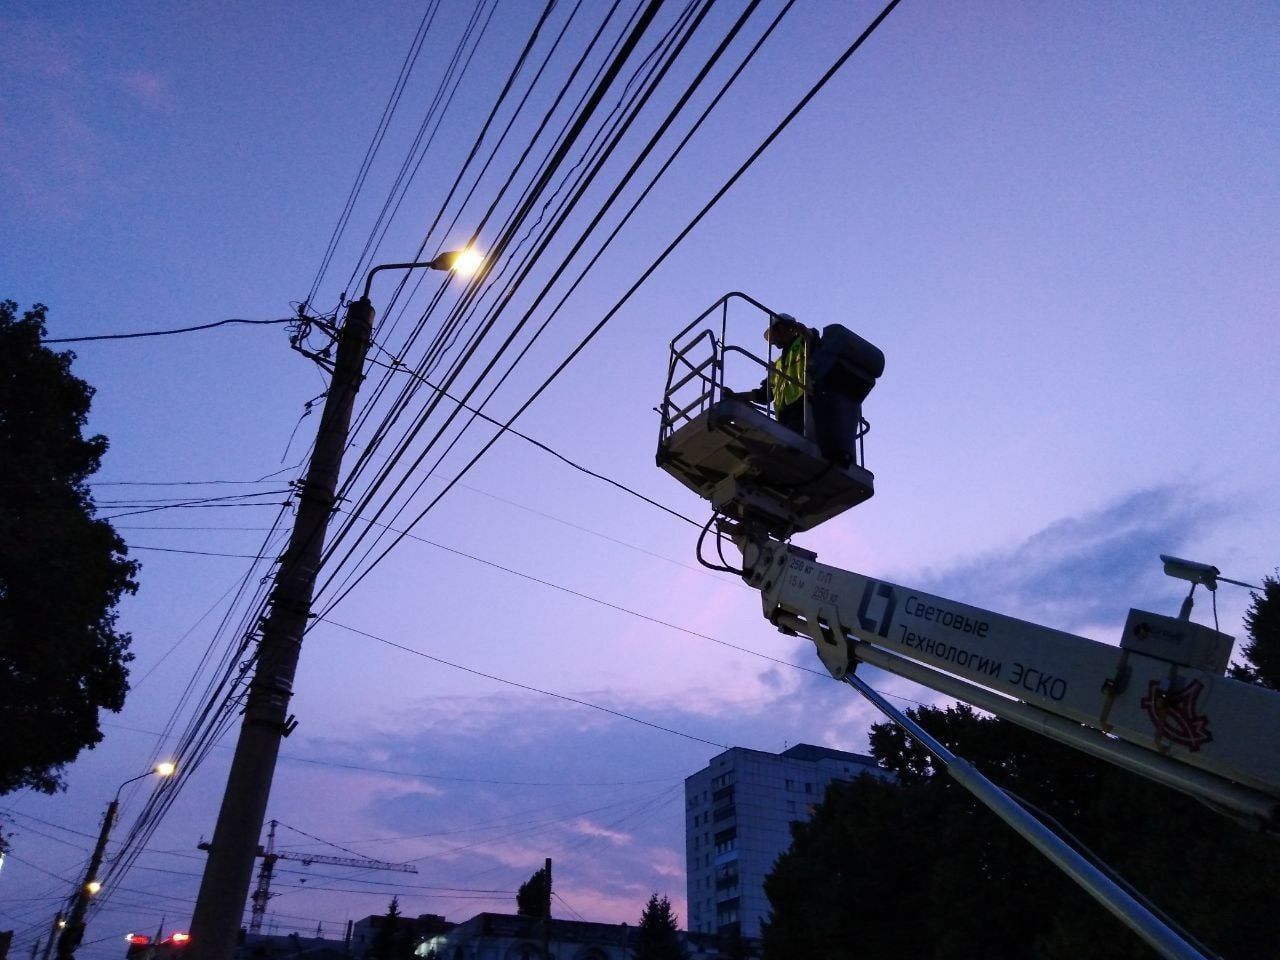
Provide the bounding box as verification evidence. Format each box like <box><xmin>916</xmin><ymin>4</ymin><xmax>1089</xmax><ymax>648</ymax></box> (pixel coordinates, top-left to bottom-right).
<box><xmin>658</xmin><ymin>293</ymin><xmax>883</xmax><ymax>540</ymax></box>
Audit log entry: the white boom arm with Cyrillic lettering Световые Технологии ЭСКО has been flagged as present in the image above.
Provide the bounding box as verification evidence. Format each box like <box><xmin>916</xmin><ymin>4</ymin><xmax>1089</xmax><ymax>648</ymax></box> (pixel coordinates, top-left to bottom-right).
<box><xmin>727</xmin><ymin>527</ymin><xmax>1280</xmax><ymax>829</ymax></box>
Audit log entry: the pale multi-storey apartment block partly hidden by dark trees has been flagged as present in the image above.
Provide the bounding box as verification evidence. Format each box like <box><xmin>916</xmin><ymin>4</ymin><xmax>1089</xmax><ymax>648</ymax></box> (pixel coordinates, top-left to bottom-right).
<box><xmin>685</xmin><ymin>744</ymin><xmax>887</xmax><ymax>937</ymax></box>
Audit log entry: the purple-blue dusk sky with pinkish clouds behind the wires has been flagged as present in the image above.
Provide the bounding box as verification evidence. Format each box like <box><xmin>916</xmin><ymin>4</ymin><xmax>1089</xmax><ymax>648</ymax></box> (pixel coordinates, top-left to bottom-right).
<box><xmin>0</xmin><ymin>0</ymin><xmax>1280</xmax><ymax>960</ymax></box>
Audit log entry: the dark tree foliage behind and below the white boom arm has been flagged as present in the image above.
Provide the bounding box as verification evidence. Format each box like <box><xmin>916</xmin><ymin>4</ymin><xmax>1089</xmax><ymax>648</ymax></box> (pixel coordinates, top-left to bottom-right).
<box><xmin>763</xmin><ymin>593</ymin><xmax>1280</xmax><ymax>960</ymax></box>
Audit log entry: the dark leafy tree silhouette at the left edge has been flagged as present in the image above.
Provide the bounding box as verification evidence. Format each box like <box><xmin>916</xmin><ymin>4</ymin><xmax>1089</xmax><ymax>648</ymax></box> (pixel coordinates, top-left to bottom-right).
<box><xmin>0</xmin><ymin>301</ymin><xmax>138</xmax><ymax>795</ymax></box>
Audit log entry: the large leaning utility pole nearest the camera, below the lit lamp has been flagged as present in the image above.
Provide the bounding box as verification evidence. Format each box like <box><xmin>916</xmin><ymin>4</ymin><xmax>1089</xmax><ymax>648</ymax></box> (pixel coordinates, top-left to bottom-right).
<box><xmin>189</xmin><ymin>299</ymin><xmax>374</xmax><ymax>960</ymax></box>
